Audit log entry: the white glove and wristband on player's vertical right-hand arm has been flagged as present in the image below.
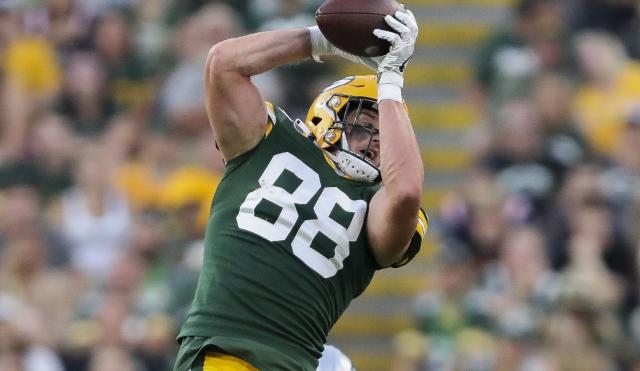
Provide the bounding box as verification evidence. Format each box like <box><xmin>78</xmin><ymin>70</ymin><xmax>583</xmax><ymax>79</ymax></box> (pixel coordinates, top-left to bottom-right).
<box><xmin>373</xmin><ymin>10</ymin><xmax>419</xmax><ymax>102</ymax></box>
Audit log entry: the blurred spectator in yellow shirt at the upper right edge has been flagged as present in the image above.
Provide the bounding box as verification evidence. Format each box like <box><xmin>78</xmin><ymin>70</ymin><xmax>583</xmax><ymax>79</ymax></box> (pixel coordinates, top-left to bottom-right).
<box><xmin>575</xmin><ymin>32</ymin><xmax>640</xmax><ymax>157</ymax></box>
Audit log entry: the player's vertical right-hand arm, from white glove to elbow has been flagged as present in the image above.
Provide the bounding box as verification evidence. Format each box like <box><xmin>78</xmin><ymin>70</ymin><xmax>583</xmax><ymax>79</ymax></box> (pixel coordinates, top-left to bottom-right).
<box><xmin>367</xmin><ymin>11</ymin><xmax>424</xmax><ymax>267</ymax></box>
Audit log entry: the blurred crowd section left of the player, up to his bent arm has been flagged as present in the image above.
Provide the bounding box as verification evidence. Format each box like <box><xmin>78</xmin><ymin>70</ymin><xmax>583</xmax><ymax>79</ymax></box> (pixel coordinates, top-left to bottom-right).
<box><xmin>0</xmin><ymin>0</ymin><xmax>331</xmax><ymax>371</ymax></box>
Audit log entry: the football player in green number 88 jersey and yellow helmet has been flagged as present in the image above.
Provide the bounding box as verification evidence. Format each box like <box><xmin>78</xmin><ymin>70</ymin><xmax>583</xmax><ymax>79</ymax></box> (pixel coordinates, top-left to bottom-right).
<box><xmin>175</xmin><ymin>6</ymin><xmax>427</xmax><ymax>371</ymax></box>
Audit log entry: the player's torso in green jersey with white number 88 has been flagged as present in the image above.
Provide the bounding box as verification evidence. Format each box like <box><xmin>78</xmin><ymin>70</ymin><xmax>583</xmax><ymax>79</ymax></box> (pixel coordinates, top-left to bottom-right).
<box><xmin>183</xmin><ymin>106</ymin><xmax>376</xmax><ymax>369</ymax></box>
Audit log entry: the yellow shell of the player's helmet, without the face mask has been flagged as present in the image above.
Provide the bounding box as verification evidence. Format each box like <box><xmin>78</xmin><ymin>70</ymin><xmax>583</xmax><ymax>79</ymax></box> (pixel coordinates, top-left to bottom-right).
<box><xmin>305</xmin><ymin>75</ymin><xmax>378</xmax><ymax>149</ymax></box>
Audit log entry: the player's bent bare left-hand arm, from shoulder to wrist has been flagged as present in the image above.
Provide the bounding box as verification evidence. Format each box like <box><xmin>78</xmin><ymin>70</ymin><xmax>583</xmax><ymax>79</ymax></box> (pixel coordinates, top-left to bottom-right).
<box><xmin>205</xmin><ymin>28</ymin><xmax>311</xmax><ymax>161</ymax></box>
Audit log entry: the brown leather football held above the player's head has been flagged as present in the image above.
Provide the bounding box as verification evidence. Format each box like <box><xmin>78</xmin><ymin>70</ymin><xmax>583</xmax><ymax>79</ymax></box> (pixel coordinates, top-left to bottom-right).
<box><xmin>316</xmin><ymin>0</ymin><xmax>402</xmax><ymax>57</ymax></box>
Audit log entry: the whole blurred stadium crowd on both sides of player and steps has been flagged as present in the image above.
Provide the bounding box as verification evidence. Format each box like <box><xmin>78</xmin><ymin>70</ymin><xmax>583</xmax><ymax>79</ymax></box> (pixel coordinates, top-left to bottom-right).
<box><xmin>0</xmin><ymin>0</ymin><xmax>640</xmax><ymax>371</ymax></box>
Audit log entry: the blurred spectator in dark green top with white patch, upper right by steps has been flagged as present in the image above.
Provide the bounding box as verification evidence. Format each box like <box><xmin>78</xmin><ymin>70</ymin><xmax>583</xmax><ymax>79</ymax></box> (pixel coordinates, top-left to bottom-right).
<box><xmin>474</xmin><ymin>0</ymin><xmax>572</xmax><ymax>113</ymax></box>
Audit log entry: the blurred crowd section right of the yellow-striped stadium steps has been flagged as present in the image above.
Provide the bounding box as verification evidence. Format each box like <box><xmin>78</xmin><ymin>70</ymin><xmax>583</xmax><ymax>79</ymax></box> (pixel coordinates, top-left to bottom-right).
<box><xmin>393</xmin><ymin>0</ymin><xmax>640</xmax><ymax>371</ymax></box>
